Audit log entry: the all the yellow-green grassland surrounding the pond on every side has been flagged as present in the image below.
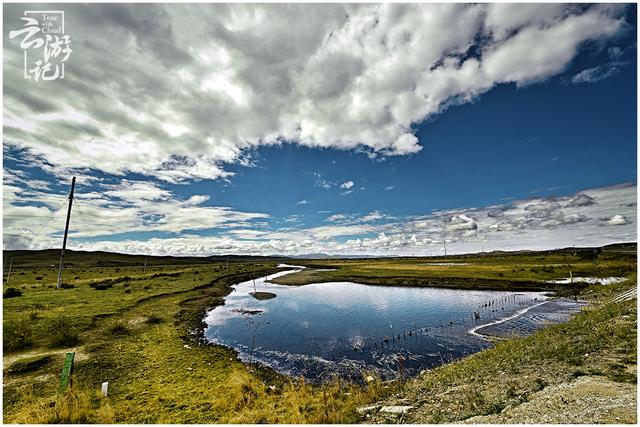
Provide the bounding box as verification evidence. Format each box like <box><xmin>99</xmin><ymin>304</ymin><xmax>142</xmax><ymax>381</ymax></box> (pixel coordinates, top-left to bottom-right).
<box><xmin>3</xmin><ymin>246</ymin><xmax>637</xmax><ymax>423</ymax></box>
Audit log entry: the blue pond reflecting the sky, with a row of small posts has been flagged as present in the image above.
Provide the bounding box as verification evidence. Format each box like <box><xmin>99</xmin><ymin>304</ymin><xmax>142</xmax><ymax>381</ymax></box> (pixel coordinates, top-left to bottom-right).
<box><xmin>205</xmin><ymin>266</ymin><xmax>583</xmax><ymax>382</ymax></box>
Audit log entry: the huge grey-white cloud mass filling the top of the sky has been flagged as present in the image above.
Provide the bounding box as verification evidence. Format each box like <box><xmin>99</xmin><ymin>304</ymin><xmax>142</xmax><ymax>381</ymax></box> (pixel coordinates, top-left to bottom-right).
<box><xmin>4</xmin><ymin>4</ymin><xmax>624</xmax><ymax>183</ymax></box>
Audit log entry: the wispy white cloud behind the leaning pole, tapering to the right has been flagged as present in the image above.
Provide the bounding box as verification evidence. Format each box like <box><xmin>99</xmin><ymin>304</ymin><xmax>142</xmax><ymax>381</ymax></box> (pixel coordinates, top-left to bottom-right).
<box><xmin>3</xmin><ymin>180</ymin><xmax>269</xmax><ymax>249</ymax></box>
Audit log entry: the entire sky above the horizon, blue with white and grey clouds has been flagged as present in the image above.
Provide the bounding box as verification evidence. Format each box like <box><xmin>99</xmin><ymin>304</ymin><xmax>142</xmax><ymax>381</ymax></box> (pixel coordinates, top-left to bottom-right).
<box><xmin>3</xmin><ymin>4</ymin><xmax>637</xmax><ymax>256</ymax></box>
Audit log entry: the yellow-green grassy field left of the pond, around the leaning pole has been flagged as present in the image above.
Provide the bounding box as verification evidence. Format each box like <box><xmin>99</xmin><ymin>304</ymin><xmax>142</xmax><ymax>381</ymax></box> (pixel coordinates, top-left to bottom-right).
<box><xmin>3</xmin><ymin>252</ymin><xmax>389</xmax><ymax>423</ymax></box>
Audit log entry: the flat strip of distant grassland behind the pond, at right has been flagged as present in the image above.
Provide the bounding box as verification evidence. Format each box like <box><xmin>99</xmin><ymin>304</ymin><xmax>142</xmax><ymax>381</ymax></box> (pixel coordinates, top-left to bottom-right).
<box><xmin>273</xmin><ymin>245</ymin><xmax>635</xmax><ymax>292</ymax></box>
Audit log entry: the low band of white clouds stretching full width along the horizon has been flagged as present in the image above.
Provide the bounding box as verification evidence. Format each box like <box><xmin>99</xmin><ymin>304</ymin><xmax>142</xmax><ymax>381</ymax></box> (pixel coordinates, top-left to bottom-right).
<box><xmin>4</xmin><ymin>181</ymin><xmax>637</xmax><ymax>255</ymax></box>
